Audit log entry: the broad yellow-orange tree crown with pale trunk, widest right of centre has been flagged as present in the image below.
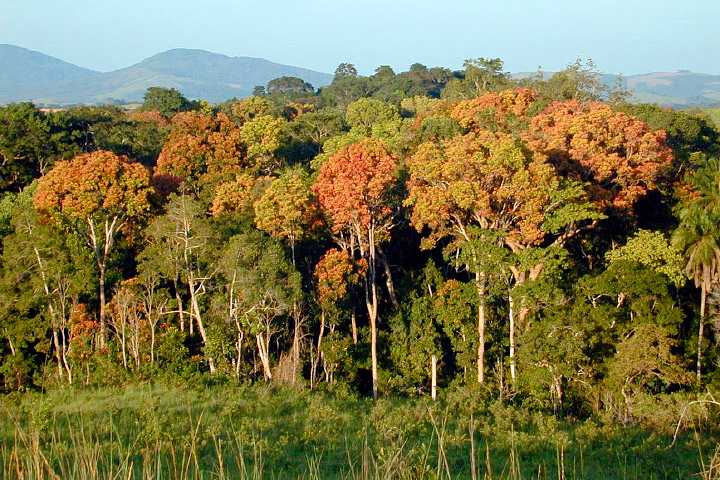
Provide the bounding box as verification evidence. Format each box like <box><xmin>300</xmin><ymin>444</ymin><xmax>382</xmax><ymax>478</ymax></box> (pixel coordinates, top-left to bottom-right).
<box><xmin>405</xmin><ymin>131</ymin><xmax>597</xmax><ymax>383</ymax></box>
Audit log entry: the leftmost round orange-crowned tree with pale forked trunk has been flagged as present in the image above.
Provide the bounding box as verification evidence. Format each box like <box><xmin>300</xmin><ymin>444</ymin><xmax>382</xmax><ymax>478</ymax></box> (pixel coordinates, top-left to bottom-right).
<box><xmin>34</xmin><ymin>151</ymin><xmax>153</xmax><ymax>342</ymax></box>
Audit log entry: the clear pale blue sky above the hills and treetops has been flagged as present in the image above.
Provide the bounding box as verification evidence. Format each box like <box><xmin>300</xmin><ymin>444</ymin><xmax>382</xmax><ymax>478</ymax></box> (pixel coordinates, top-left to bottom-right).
<box><xmin>0</xmin><ymin>0</ymin><xmax>720</xmax><ymax>74</ymax></box>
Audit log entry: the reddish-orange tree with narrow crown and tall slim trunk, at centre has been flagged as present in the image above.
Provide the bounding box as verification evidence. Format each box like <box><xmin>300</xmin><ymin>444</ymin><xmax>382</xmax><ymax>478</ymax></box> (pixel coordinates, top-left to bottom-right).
<box><xmin>313</xmin><ymin>139</ymin><xmax>398</xmax><ymax>398</ymax></box>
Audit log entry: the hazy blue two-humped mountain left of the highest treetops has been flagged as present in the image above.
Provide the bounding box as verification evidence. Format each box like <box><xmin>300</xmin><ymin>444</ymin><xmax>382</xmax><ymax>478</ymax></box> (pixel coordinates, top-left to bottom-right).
<box><xmin>0</xmin><ymin>45</ymin><xmax>332</xmax><ymax>105</ymax></box>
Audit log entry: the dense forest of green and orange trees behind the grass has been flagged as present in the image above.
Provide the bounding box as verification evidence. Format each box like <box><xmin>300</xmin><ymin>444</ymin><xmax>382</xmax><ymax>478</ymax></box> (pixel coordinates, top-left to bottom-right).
<box><xmin>0</xmin><ymin>58</ymin><xmax>720</xmax><ymax>436</ymax></box>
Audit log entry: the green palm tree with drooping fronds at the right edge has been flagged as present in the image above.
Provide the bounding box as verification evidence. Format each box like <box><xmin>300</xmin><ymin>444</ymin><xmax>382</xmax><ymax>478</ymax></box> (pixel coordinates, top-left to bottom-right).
<box><xmin>673</xmin><ymin>159</ymin><xmax>720</xmax><ymax>383</ymax></box>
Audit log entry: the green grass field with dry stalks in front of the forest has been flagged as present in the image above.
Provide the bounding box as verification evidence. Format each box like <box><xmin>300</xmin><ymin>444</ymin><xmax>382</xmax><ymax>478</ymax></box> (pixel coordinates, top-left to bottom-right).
<box><xmin>0</xmin><ymin>386</ymin><xmax>720</xmax><ymax>480</ymax></box>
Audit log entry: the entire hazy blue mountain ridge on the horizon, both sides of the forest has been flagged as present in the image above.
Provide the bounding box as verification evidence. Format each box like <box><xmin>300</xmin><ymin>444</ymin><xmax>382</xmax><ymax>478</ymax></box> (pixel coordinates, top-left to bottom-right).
<box><xmin>0</xmin><ymin>44</ymin><xmax>720</xmax><ymax>108</ymax></box>
